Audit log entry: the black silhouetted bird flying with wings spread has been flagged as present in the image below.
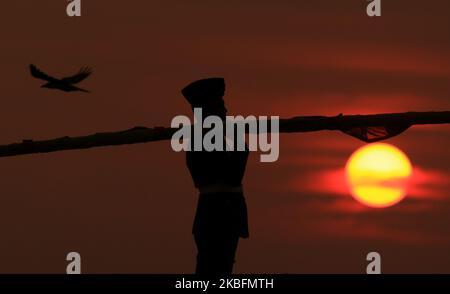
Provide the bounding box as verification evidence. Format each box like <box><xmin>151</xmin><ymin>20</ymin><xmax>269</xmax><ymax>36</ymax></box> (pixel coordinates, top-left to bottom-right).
<box><xmin>30</xmin><ymin>64</ymin><xmax>92</xmax><ymax>93</ymax></box>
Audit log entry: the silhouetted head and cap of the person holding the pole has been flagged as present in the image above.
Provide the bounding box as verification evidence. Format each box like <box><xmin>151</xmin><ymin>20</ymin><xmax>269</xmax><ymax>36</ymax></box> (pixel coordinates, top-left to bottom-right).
<box><xmin>181</xmin><ymin>78</ymin><xmax>227</xmax><ymax>119</ymax></box>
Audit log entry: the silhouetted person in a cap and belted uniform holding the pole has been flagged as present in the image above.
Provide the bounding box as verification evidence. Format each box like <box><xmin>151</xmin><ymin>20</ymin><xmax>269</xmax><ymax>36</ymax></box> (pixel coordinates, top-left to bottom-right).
<box><xmin>182</xmin><ymin>78</ymin><xmax>249</xmax><ymax>275</ymax></box>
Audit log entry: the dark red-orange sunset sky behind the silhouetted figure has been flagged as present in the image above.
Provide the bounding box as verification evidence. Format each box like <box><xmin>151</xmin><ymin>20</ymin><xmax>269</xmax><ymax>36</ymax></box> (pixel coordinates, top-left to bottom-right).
<box><xmin>0</xmin><ymin>0</ymin><xmax>450</xmax><ymax>273</ymax></box>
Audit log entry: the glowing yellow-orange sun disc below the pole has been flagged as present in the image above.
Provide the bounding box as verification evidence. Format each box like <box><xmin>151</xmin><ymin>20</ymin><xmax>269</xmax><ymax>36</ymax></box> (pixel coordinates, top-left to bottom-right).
<box><xmin>345</xmin><ymin>143</ymin><xmax>412</xmax><ymax>208</ymax></box>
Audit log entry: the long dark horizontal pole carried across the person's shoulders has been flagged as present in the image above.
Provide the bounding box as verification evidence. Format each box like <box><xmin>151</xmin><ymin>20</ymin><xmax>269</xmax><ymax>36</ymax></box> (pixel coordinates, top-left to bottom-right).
<box><xmin>0</xmin><ymin>111</ymin><xmax>450</xmax><ymax>157</ymax></box>
